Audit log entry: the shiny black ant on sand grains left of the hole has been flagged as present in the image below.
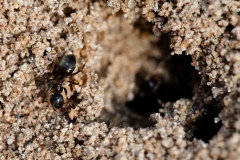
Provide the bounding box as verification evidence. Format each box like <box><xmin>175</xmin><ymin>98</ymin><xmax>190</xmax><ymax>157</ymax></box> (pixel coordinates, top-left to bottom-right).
<box><xmin>49</xmin><ymin>54</ymin><xmax>85</xmax><ymax>109</ymax></box>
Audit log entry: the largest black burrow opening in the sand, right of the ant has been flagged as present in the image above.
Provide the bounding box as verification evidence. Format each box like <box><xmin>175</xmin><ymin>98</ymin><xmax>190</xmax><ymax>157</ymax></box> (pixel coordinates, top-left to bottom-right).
<box><xmin>126</xmin><ymin>54</ymin><xmax>200</xmax><ymax>117</ymax></box>
